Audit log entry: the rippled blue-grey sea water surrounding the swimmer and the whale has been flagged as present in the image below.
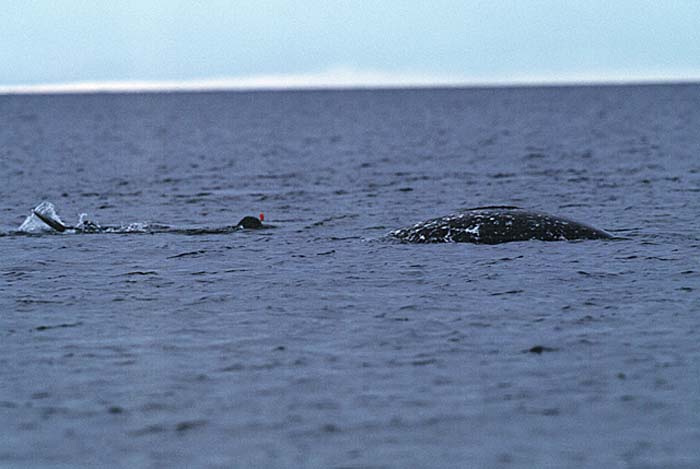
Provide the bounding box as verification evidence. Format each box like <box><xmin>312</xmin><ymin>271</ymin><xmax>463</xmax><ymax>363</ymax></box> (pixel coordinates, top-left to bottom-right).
<box><xmin>0</xmin><ymin>85</ymin><xmax>700</xmax><ymax>469</ymax></box>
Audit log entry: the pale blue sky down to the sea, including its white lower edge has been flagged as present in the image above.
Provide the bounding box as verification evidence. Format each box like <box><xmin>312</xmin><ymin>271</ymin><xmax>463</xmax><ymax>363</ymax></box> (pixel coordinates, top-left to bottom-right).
<box><xmin>0</xmin><ymin>0</ymin><xmax>700</xmax><ymax>86</ymax></box>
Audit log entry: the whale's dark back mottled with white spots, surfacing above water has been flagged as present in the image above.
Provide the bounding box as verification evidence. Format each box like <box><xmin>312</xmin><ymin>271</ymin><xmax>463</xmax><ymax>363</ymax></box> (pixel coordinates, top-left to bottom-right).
<box><xmin>390</xmin><ymin>206</ymin><xmax>613</xmax><ymax>244</ymax></box>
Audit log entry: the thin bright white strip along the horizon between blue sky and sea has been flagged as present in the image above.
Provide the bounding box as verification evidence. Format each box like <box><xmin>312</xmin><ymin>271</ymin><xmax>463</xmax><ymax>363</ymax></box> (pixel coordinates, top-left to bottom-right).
<box><xmin>0</xmin><ymin>69</ymin><xmax>700</xmax><ymax>95</ymax></box>
